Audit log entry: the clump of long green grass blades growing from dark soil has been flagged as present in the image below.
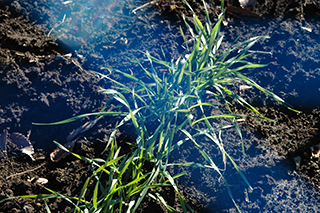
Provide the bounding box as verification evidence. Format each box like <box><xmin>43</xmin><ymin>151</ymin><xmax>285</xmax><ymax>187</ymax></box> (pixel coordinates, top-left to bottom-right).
<box><xmin>0</xmin><ymin>1</ymin><xmax>300</xmax><ymax>212</ymax></box>
